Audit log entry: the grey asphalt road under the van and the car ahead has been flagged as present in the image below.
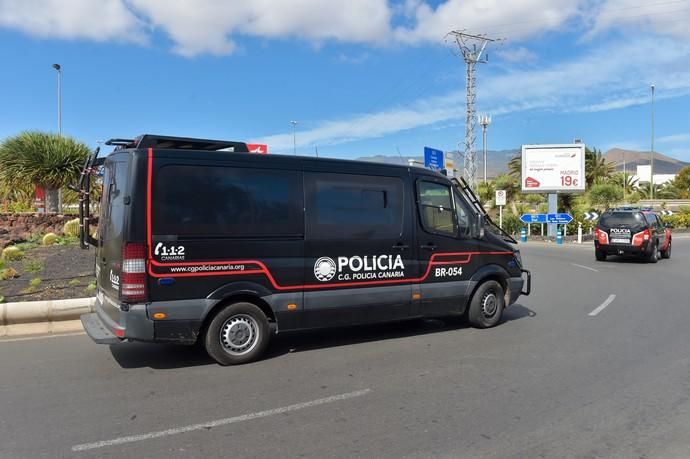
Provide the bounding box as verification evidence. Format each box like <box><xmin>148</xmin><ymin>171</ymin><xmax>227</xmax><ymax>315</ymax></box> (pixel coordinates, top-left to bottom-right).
<box><xmin>0</xmin><ymin>237</ymin><xmax>690</xmax><ymax>459</ymax></box>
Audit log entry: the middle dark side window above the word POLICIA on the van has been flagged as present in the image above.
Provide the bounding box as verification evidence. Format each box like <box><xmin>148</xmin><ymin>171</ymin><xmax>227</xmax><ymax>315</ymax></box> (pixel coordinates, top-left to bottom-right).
<box><xmin>304</xmin><ymin>173</ymin><xmax>404</xmax><ymax>240</ymax></box>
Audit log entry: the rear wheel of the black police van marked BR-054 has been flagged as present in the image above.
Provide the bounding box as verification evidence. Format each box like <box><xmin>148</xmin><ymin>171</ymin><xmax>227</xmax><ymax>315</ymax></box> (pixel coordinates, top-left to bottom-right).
<box><xmin>204</xmin><ymin>302</ymin><xmax>271</xmax><ymax>365</ymax></box>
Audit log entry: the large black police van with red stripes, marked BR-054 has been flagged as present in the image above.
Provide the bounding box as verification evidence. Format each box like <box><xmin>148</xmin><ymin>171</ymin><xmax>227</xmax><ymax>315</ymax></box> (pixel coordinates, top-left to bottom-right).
<box><xmin>79</xmin><ymin>135</ymin><xmax>531</xmax><ymax>365</ymax></box>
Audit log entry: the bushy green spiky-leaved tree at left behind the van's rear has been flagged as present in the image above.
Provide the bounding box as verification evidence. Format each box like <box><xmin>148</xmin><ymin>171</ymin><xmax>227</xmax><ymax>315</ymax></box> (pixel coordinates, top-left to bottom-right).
<box><xmin>0</xmin><ymin>131</ymin><xmax>89</xmax><ymax>212</ymax></box>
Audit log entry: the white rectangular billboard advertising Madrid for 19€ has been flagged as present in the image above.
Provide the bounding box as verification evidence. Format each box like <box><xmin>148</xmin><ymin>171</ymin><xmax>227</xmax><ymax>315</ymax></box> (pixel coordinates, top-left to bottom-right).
<box><xmin>522</xmin><ymin>143</ymin><xmax>585</xmax><ymax>193</ymax></box>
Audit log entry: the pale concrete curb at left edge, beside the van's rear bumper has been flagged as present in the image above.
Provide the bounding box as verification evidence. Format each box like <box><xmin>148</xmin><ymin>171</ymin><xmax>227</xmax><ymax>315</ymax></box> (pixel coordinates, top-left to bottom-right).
<box><xmin>0</xmin><ymin>297</ymin><xmax>96</xmax><ymax>337</ymax></box>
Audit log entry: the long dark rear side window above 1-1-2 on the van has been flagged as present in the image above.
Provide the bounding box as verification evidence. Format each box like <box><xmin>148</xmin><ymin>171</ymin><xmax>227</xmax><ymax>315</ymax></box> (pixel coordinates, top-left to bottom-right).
<box><xmin>152</xmin><ymin>165</ymin><xmax>304</xmax><ymax>238</ymax></box>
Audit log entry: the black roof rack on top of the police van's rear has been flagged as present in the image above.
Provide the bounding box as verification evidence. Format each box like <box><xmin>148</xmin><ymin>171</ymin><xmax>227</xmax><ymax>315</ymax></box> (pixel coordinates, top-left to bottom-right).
<box><xmin>105</xmin><ymin>134</ymin><xmax>249</xmax><ymax>153</ymax></box>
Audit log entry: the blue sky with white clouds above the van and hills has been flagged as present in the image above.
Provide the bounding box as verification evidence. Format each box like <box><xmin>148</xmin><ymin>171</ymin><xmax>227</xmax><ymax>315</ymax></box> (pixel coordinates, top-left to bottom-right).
<box><xmin>0</xmin><ymin>0</ymin><xmax>690</xmax><ymax>161</ymax></box>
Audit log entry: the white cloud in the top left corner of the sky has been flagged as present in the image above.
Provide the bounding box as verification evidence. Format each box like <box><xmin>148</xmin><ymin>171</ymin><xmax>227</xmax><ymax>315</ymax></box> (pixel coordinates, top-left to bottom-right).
<box><xmin>0</xmin><ymin>0</ymin><xmax>145</xmax><ymax>43</ymax></box>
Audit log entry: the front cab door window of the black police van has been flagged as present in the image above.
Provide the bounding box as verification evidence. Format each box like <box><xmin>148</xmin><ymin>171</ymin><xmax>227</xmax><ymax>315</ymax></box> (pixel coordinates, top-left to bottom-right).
<box><xmin>417</xmin><ymin>181</ymin><xmax>457</xmax><ymax>236</ymax></box>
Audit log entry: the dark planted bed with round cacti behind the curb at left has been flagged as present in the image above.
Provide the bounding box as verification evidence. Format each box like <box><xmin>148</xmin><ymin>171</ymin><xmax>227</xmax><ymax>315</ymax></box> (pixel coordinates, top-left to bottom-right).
<box><xmin>0</xmin><ymin>243</ymin><xmax>96</xmax><ymax>303</ymax></box>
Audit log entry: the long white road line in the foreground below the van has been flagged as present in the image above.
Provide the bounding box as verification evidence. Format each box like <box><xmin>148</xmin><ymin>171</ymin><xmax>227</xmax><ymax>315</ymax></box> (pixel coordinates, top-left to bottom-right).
<box><xmin>72</xmin><ymin>389</ymin><xmax>371</xmax><ymax>451</ymax></box>
